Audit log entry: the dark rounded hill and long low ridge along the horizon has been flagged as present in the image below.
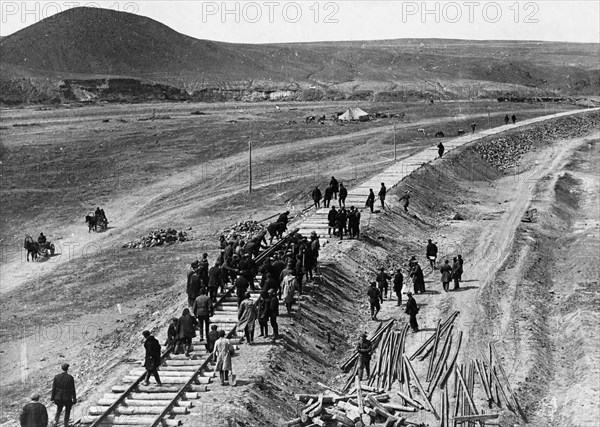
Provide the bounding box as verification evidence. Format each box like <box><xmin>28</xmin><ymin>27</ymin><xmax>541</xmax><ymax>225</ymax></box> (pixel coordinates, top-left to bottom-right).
<box><xmin>0</xmin><ymin>7</ymin><xmax>600</xmax><ymax>102</ymax></box>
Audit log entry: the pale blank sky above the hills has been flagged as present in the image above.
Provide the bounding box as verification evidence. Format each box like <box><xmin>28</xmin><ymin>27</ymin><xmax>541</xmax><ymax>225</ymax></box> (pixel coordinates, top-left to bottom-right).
<box><xmin>0</xmin><ymin>0</ymin><xmax>600</xmax><ymax>43</ymax></box>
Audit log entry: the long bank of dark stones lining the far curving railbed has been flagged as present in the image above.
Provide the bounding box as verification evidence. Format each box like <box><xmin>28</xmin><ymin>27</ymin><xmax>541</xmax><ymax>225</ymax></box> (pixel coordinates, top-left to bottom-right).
<box><xmin>474</xmin><ymin>113</ymin><xmax>600</xmax><ymax>172</ymax></box>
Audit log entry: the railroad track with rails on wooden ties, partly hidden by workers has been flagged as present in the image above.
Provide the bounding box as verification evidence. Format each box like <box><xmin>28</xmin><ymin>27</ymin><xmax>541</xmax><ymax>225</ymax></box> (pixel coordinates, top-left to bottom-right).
<box><xmin>76</xmin><ymin>229</ymin><xmax>298</xmax><ymax>427</ymax></box>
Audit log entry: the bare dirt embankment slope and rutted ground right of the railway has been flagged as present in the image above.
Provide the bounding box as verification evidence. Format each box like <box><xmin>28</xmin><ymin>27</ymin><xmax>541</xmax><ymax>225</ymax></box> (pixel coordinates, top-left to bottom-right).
<box><xmin>205</xmin><ymin>114</ymin><xmax>600</xmax><ymax>426</ymax></box>
